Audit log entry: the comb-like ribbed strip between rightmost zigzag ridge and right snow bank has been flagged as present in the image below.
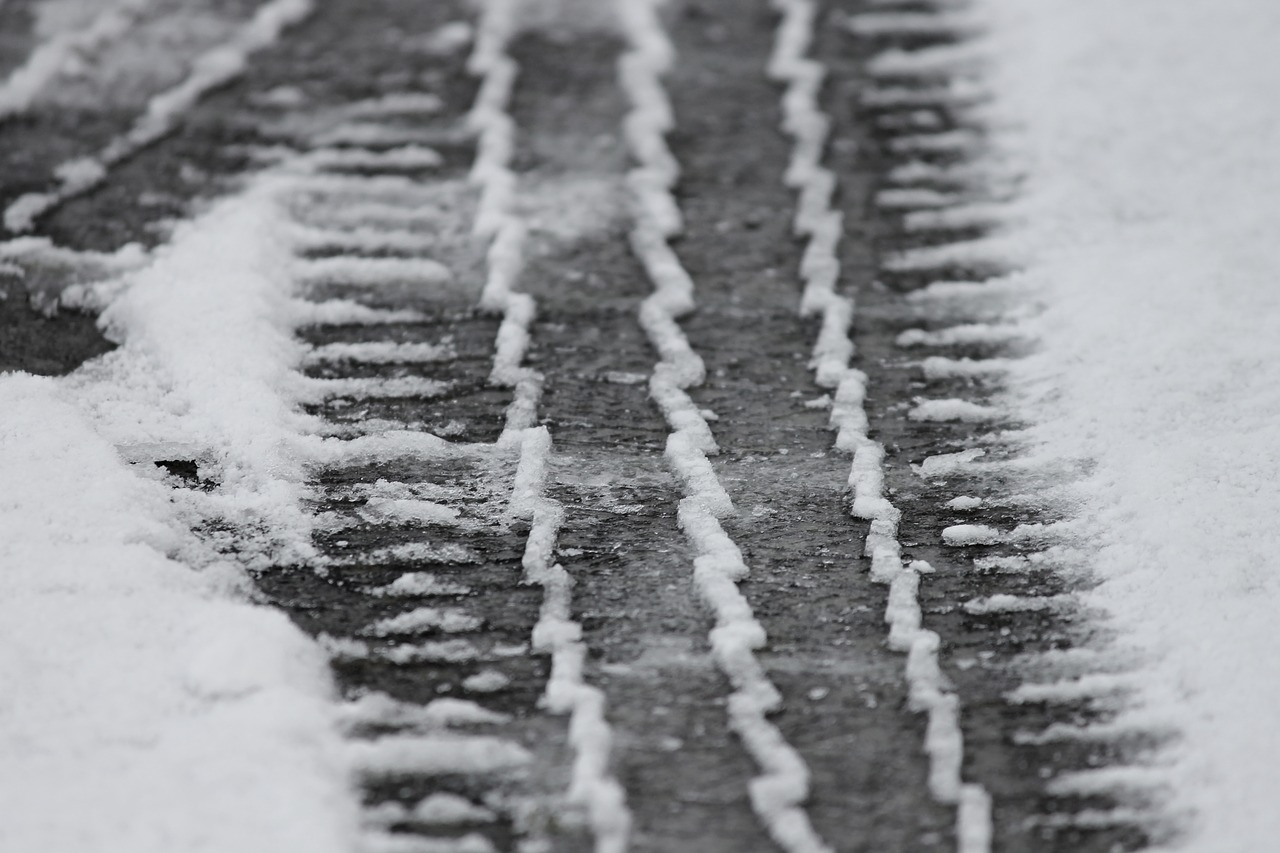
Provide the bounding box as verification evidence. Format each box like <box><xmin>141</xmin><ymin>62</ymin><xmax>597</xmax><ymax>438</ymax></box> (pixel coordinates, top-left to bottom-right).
<box><xmin>822</xmin><ymin>4</ymin><xmax>1165</xmax><ymax>850</ymax></box>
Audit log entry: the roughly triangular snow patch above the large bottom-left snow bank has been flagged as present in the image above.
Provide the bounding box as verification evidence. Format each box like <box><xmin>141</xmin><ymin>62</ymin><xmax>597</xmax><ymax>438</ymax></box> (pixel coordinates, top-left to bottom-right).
<box><xmin>67</xmin><ymin>179</ymin><xmax>312</xmax><ymax>560</ymax></box>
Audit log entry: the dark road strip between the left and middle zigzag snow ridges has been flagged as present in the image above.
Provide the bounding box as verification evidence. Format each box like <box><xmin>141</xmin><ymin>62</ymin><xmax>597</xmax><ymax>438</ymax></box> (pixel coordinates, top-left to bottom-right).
<box><xmin>513</xmin><ymin>21</ymin><xmax>769</xmax><ymax>853</ymax></box>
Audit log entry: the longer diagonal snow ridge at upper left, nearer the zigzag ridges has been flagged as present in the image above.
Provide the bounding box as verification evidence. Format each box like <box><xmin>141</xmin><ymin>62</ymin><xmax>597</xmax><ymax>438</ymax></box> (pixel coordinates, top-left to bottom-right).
<box><xmin>4</xmin><ymin>0</ymin><xmax>314</xmax><ymax>232</ymax></box>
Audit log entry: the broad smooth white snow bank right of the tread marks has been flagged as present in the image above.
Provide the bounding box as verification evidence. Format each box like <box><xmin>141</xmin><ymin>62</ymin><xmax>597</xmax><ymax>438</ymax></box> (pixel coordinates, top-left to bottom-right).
<box><xmin>978</xmin><ymin>0</ymin><xmax>1280</xmax><ymax>853</ymax></box>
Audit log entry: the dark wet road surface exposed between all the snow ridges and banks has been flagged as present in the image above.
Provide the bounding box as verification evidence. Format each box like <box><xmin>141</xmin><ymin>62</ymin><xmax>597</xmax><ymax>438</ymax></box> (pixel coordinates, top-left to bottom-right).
<box><xmin>0</xmin><ymin>0</ymin><xmax>1156</xmax><ymax>853</ymax></box>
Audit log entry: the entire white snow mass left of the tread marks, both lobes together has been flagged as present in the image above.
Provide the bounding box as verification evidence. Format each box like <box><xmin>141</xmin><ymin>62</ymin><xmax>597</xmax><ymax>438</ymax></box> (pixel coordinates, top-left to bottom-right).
<box><xmin>0</xmin><ymin>179</ymin><xmax>357</xmax><ymax>853</ymax></box>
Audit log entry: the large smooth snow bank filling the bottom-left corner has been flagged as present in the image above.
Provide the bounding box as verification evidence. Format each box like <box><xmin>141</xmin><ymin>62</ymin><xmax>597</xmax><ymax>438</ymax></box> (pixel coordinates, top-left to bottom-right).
<box><xmin>0</xmin><ymin>375</ymin><xmax>356</xmax><ymax>853</ymax></box>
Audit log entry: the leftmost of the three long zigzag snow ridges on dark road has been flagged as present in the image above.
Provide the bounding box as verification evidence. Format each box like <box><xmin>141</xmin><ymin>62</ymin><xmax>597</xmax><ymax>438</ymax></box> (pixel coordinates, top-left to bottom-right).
<box><xmin>467</xmin><ymin>0</ymin><xmax>631</xmax><ymax>853</ymax></box>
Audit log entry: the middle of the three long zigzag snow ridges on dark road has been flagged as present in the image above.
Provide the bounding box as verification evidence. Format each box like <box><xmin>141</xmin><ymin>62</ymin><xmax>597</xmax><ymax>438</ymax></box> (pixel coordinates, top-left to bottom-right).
<box><xmin>617</xmin><ymin>0</ymin><xmax>831</xmax><ymax>853</ymax></box>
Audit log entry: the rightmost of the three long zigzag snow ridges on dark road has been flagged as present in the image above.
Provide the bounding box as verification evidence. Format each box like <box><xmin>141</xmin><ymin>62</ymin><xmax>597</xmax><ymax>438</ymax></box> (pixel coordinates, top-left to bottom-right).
<box><xmin>768</xmin><ymin>0</ymin><xmax>992</xmax><ymax>853</ymax></box>
